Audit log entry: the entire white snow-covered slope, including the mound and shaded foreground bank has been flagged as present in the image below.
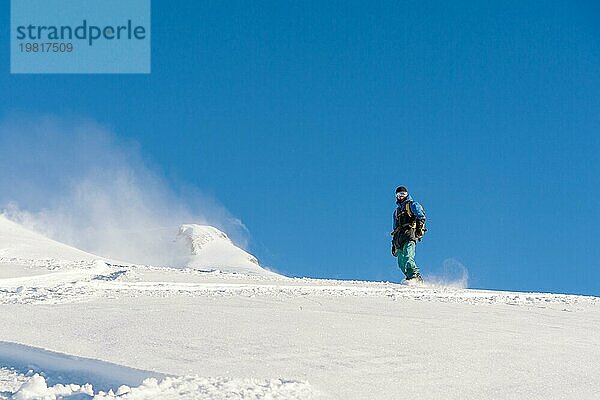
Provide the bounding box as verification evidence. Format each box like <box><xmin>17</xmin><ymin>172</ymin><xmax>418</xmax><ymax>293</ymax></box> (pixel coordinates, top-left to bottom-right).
<box><xmin>0</xmin><ymin>217</ymin><xmax>600</xmax><ymax>400</ymax></box>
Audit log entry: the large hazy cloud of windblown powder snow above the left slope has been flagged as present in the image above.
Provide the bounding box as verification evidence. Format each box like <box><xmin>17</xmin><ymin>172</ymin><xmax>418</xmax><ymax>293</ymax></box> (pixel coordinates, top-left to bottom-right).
<box><xmin>0</xmin><ymin>115</ymin><xmax>247</xmax><ymax>265</ymax></box>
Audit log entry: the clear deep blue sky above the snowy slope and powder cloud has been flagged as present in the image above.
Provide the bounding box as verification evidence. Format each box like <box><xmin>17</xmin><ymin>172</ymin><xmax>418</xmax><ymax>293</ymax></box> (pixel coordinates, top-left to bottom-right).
<box><xmin>0</xmin><ymin>0</ymin><xmax>600</xmax><ymax>295</ymax></box>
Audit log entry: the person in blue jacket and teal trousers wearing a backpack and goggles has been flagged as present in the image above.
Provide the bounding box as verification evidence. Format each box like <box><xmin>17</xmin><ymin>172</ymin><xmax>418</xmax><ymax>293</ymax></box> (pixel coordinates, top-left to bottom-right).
<box><xmin>392</xmin><ymin>186</ymin><xmax>427</xmax><ymax>283</ymax></box>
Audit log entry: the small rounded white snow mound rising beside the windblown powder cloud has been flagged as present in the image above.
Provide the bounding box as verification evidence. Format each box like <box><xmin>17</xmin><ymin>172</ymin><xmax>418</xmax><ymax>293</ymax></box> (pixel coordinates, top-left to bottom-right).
<box><xmin>179</xmin><ymin>224</ymin><xmax>274</xmax><ymax>275</ymax></box>
